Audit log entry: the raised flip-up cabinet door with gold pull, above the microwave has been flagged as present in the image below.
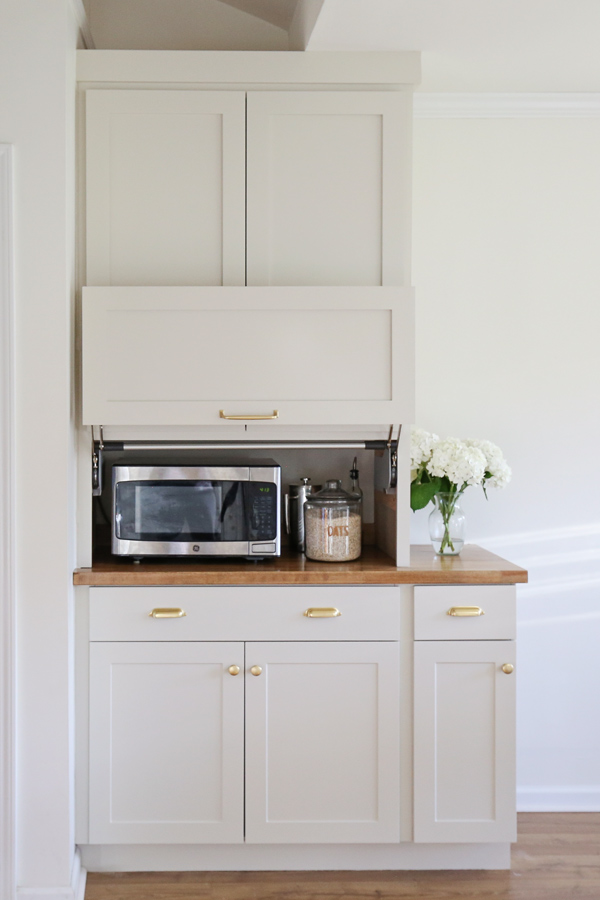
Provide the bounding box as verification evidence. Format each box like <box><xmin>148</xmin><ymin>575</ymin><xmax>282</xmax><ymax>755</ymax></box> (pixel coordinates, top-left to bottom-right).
<box><xmin>83</xmin><ymin>286</ymin><xmax>414</xmax><ymax>428</ymax></box>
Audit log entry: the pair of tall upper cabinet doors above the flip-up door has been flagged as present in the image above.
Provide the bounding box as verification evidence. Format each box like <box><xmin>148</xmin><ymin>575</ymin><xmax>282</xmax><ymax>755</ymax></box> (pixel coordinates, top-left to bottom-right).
<box><xmin>86</xmin><ymin>90</ymin><xmax>411</xmax><ymax>286</ymax></box>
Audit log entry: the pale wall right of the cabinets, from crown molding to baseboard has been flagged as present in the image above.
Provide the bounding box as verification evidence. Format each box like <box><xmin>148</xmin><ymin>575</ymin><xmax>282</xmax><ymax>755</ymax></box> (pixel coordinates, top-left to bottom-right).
<box><xmin>412</xmin><ymin>112</ymin><xmax>600</xmax><ymax>810</ymax></box>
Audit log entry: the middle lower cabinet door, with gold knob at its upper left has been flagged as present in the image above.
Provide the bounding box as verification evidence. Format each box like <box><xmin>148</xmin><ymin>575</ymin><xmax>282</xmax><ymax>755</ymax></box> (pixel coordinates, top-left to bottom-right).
<box><xmin>241</xmin><ymin>641</ymin><xmax>400</xmax><ymax>843</ymax></box>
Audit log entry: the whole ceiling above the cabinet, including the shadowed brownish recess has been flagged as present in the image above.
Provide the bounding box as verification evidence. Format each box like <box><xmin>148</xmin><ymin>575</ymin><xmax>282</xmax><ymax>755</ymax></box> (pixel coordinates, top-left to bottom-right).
<box><xmin>86</xmin><ymin>0</ymin><xmax>600</xmax><ymax>92</ymax></box>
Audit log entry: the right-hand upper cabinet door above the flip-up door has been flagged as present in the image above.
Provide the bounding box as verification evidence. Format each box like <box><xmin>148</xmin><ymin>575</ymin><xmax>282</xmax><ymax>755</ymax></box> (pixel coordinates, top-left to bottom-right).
<box><xmin>247</xmin><ymin>91</ymin><xmax>410</xmax><ymax>285</ymax></box>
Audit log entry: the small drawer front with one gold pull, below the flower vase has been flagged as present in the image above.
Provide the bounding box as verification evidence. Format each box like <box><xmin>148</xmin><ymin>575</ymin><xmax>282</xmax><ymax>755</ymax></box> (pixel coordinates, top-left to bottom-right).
<box><xmin>415</xmin><ymin>584</ymin><xmax>516</xmax><ymax>641</ymax></box>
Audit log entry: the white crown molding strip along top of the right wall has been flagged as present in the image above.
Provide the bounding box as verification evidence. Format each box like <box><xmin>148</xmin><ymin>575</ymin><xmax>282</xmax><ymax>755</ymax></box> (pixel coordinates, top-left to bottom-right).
<box><xmin>414</xmin><ymin>92</ymin><xmax>600</xmax><ymax>119</ymax></box>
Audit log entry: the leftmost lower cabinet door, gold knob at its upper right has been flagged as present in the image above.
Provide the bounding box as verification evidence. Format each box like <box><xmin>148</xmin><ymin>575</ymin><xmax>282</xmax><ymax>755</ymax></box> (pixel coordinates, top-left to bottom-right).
<box><xmin>89</xmin><ymin>641</ymin><xmax>244</xmax><ymax>844</ymax></box>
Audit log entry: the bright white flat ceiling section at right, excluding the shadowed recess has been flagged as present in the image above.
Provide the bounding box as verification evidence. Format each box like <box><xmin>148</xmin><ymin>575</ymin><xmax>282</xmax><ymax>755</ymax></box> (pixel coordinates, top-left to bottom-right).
<box><xmin>308</xmin><ymin>0</ymin><xmax>600</xmax><ymax>91</ymax></box>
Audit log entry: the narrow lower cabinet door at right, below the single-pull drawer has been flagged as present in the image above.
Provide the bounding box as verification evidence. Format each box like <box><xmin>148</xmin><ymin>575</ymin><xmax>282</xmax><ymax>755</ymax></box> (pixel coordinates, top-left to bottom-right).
<box><xmin>414</xmin><ymin>641</ymin><xmax>517</xmax><ymax>843</ymax></box>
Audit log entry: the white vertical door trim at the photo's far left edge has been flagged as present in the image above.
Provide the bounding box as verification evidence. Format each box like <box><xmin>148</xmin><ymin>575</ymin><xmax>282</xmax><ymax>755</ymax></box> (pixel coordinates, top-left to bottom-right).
<box><xmin>0</xmin><ymin>144</ymin><xmax>16</xmax><ymax>900</ymax></box>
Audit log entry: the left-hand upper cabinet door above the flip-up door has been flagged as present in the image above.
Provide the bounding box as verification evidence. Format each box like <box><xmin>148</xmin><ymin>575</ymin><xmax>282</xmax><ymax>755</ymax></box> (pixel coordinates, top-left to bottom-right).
<box><xmin>86</xmin><ymin>90</ymin><xmax>245</xmax><ymax>285</ymax></box>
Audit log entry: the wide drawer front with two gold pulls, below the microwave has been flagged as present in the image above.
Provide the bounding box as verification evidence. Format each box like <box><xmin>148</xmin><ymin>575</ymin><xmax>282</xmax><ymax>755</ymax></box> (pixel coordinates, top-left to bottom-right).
<box><xmin>90</xmin><ymin>585</ymin><xmax>400</xmax><ymax>641</ymax></box>
